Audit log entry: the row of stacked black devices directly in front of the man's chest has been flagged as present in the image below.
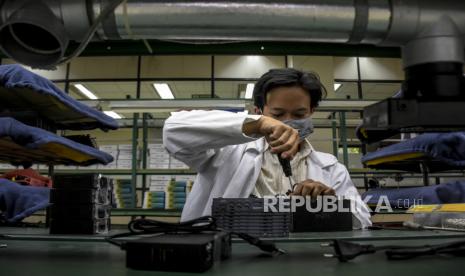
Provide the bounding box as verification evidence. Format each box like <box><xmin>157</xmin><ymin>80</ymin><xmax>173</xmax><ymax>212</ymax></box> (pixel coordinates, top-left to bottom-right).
<box><xmin>212</xmin><ymin>198</ymin><xmax>352</xmax><ymax>238</ymax></box>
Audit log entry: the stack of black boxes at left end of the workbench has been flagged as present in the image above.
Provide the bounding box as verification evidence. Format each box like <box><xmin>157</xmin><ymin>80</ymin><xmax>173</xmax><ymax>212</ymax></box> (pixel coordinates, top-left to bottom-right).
<box><xmin>50</xmin><ymin>174</ymin><xmax>112</xmax><ymax>234</ymax></box>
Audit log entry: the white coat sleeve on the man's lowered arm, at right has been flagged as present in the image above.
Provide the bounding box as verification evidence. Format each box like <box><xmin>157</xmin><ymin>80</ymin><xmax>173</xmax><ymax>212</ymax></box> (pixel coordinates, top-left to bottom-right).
<box><xmin>332</xmin><ymin>162</ymin><xmax>371</xmax><ymax>228</ymax></box>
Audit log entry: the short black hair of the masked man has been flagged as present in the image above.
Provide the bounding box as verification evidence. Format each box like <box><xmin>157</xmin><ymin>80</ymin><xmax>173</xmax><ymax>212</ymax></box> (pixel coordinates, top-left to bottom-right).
<box><xmin>253</xmin><ymin>68</ymin><xmax>326</xmax><ymax>110</ymax></box>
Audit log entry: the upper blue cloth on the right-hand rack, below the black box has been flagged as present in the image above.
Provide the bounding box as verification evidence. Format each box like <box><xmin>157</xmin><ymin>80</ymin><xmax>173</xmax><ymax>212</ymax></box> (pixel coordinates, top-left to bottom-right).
<box><xmin>362</xmin><ymin>132</ymin><xmax>465</xmax><ymax>169</ymax></box>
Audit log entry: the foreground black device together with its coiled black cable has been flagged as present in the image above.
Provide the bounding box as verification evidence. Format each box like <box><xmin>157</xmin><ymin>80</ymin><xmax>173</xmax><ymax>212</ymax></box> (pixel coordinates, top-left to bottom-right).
<box><xmin>106</xmin><ymin>216</ymin><xmax>284</xmax><ymax>272</ymax></box>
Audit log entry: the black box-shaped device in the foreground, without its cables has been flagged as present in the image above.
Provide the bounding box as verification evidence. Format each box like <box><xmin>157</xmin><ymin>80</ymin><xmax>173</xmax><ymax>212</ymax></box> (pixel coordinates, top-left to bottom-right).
<box><xmin>123</xmin><ymin>232</ymin><xmax>231</xmax><ymax>272</ymax></box>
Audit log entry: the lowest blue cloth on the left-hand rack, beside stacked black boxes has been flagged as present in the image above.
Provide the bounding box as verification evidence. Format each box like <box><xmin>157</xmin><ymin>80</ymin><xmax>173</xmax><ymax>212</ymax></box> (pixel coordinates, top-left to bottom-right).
<box><xmin>0</xmin><ymin>179</ymin><xmax>50</xmax><ymax>222</ymax></box>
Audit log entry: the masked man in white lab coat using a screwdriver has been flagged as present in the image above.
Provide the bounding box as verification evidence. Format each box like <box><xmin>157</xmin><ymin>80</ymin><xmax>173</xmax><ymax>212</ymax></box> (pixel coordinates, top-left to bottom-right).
<box><xmin>163</xmin><ymin>68</ymin><xmax>371</xmax><ymax>227</ymax></box>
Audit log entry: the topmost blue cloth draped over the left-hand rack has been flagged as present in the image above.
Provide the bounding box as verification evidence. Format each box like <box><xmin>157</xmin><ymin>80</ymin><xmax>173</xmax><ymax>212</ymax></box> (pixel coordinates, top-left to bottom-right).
<box><xmin>0</xmin><ymin>64</ymin><xmax>118</xmax><ymax>129</ymax></box>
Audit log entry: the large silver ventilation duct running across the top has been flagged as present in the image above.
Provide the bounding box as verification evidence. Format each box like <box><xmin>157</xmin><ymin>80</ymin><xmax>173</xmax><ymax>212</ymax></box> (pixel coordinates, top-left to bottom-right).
<box><xmin>0</xmin><ymin>0</ymin><xmax>465</xmax><ymax>67</ymax></box>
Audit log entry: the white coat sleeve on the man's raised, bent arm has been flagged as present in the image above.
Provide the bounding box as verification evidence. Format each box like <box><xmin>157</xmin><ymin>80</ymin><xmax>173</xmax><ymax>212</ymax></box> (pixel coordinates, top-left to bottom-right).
<box><xmin>163</xmin><ymin>110</ymin><xmax>259</xmax><ymax>172</ymax></box>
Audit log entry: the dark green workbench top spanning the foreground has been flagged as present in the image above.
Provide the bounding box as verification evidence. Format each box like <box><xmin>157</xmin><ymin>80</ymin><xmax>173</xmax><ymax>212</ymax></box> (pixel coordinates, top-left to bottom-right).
<box><xmin>0</xmin><ymin>227</ymin><xmax>465</xmax><ymax>276</ymax></box>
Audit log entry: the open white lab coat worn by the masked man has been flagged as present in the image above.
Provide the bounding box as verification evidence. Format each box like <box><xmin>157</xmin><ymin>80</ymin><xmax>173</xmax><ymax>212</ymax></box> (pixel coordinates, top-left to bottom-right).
<box><xmin>163</xmin><ymin>110</ymin><xmax>371</xmax><ymax>227</ymax></box>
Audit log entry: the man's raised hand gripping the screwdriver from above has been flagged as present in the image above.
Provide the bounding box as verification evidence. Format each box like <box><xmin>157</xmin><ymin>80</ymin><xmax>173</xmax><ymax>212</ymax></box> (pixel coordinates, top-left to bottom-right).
<box><xmin>242</xmin><ymin>116</ymin><xmax>300</xmax><ymax>159</ymax></box>
